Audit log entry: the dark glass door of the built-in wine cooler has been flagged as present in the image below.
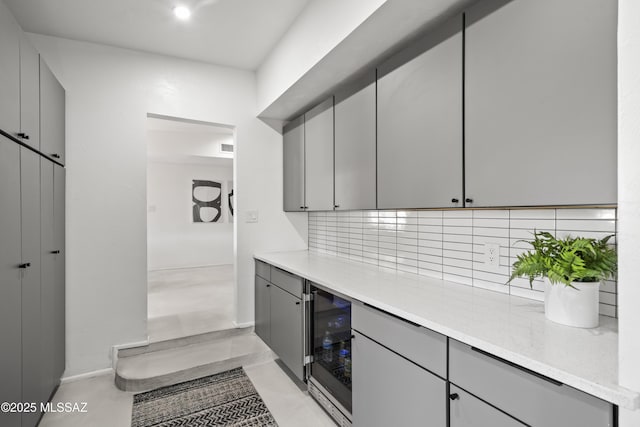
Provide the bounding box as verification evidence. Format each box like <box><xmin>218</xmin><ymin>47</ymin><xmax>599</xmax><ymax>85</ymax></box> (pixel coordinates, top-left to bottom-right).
<box><xmin>311</xmin><ymin>288</ymin><xmax>351</xmax><ymax>412</ymax></box>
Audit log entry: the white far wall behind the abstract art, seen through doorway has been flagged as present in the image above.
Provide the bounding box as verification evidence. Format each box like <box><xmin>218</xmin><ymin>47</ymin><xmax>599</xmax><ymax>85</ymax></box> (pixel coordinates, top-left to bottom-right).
<box><xmin>147</xmin><ymin>159</ymin><xmax>233</xmax><ymax>270</ymax></box>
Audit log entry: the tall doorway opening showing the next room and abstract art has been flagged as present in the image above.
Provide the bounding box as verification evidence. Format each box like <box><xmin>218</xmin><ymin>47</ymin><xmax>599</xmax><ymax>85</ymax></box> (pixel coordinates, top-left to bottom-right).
<box><xmin>147</xmin><ymin>114</ymin><xmax>235</xmax><ymax>343</ymax></box>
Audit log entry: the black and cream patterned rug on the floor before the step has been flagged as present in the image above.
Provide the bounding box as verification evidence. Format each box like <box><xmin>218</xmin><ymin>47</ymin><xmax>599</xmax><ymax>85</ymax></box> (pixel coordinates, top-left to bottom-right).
<box><xmin>131</xmin><ymin>368</ymin><xmax>277</xmax><ymax>427</ymax></box>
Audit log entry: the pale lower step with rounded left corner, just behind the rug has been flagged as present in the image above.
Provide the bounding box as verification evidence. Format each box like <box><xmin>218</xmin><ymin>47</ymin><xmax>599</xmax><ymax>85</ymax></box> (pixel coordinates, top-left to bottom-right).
<box><xmin>115</xmin><ymin>332</ymin><xmax>275</xmax><ymax>392</ymax></box>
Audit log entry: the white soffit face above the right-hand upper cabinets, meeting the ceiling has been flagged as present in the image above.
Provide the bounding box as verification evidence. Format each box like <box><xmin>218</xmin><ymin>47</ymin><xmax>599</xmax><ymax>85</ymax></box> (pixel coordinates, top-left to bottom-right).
<box><xmin>257</xmin><ymin>0</ymin><xmax>386</xmax><ymax>112</ymax></box>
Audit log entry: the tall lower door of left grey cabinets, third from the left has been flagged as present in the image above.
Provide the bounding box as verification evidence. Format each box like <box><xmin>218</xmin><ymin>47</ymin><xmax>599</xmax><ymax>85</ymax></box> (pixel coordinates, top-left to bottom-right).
<box><xmin>40</xmin><ymin>157</ymin><xmax>58</xmax><ymax>401</ymax></box>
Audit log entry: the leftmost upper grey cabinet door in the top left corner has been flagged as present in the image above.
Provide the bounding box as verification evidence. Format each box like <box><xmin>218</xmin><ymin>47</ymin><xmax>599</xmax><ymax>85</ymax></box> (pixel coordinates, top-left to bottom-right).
<box><xmin>0</xmin><ymin>2</ymin><xmax>21</xmax><ymax>136</ymax></box>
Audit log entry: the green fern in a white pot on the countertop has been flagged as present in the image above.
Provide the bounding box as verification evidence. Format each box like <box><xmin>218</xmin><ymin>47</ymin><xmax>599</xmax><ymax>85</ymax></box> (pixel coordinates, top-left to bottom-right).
<box><xmin>507</xmin><ymin>231</ymin><xmax>618</xmax><ymax>328</ymax></box>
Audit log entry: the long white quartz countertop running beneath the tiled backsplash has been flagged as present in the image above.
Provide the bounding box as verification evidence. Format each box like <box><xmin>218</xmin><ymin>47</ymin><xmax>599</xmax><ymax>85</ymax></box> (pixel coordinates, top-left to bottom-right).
<box><xmin>256</xmin><ymin>251</ymin><xmax>640</xmax><ymax>410</ymax></box>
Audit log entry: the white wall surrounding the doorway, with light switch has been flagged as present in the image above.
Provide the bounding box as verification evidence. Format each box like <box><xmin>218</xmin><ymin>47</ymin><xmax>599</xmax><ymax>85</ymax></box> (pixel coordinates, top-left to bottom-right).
<box><xmin>29</xmin><ymin>34</ymin><xmax>307</xmax><ymax>376</ymax></box>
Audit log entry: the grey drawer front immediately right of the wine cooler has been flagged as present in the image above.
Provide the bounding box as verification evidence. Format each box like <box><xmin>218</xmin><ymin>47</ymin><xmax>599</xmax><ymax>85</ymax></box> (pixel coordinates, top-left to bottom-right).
<box><xmin>351</xmin><ymin>304</ymin><xmax>447</xmax><ymax>378</ymax></box>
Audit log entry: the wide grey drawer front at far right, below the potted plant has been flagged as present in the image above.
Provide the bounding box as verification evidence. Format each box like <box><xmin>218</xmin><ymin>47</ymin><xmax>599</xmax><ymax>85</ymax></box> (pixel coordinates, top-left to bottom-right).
<box><xmin>449</xmin><ymin>340</ymin><xmax>613</xmax><ymax>427</ymax></box>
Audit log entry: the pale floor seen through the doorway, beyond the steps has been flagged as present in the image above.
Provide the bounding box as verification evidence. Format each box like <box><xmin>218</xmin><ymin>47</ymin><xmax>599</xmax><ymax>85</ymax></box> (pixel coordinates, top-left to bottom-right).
<box><xmin>147</xmin><ymin>265</ymin><xmax>234</xmax><ymax>342</ymax></box>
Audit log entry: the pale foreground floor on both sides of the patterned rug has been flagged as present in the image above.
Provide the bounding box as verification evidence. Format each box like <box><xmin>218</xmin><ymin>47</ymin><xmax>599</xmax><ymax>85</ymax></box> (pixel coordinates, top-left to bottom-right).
<box><xmin>40</xmin><ymin>362</ymin><xmax>335</xmax><ymax>427</ymax></box>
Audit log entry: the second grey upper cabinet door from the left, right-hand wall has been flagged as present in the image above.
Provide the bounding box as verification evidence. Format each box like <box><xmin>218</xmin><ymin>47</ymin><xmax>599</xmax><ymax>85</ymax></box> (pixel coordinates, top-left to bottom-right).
<box><xmin>304</xmin><ymin>97</ymin><xmax>334</xmax><ymax>211</ymax></box>
